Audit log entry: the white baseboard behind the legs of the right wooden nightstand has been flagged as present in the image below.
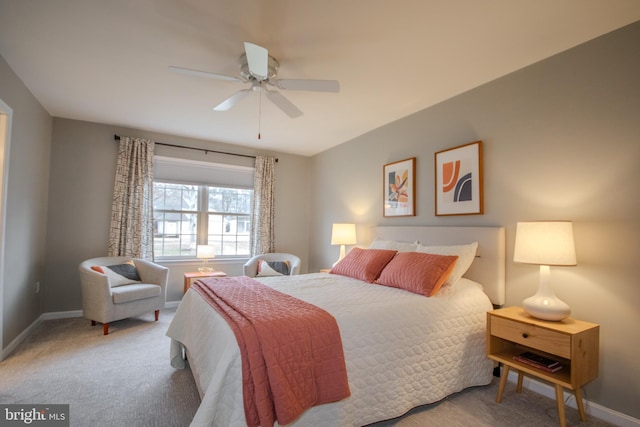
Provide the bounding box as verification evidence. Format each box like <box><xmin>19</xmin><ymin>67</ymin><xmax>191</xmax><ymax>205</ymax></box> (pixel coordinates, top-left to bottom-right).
<box><xmin>507</xmin><ymin>371</ymin><xmax>640</xmax><ymax>427</ymax></box>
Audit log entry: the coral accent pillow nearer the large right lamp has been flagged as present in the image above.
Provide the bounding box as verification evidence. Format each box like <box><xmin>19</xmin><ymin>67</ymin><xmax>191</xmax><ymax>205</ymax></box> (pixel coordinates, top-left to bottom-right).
<box><xmin>376</xmin><ymin>252</ymin><xmax>458</xmax><ymax>297</ymax></box>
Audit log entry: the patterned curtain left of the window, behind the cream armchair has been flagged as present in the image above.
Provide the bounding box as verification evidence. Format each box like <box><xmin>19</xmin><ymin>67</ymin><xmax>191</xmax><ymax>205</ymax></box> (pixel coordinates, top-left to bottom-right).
<box><xmin>109</xmin><ymin>136</ymin><xmax>154</xmax><ymax>260</ymax></box>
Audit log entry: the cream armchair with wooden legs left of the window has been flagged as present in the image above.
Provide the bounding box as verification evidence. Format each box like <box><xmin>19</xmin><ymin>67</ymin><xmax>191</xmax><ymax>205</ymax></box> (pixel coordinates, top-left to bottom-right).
<box><xmin>78</xmin><ymin>257</ymin><xmax>169</xmax><ymax>335</ymax></box>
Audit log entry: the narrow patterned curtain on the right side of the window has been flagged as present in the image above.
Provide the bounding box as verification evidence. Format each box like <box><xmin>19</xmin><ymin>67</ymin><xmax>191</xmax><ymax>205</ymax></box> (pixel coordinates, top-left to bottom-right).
<box><xmin>251</xmin><ymin>156</ymin><xmax>276</xmax><ymax>256</ymax></box>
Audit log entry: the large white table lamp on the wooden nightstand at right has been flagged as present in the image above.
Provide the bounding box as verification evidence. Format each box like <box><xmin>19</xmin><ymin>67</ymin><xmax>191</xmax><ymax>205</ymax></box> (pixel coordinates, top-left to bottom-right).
<box><xmin>513</xmin><ymin>221</ymin><xmax>577</xmax><ymax>321</ymax></box>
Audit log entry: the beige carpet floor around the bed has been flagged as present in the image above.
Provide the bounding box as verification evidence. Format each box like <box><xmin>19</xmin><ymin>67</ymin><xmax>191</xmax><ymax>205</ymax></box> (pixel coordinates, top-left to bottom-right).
<box><xmin>0</xmin><ymin>309</ymin><xmax>608</xmax><ymax>427</ymax></box>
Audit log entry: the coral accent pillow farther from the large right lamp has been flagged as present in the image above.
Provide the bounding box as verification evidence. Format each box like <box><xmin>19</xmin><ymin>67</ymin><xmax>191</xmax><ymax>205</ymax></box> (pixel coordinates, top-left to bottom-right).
<box><xmin>331</xmin><ymin>248</ymin><xmax>397</xmax><ymax>283</ymax></box>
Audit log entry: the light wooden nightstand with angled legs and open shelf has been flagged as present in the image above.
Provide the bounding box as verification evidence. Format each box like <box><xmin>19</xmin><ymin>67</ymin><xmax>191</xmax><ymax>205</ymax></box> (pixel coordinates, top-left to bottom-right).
<box><xmin>487</xmin><ymin>307</ymin><xmax>600</xmax><ymax>427</ymax></box>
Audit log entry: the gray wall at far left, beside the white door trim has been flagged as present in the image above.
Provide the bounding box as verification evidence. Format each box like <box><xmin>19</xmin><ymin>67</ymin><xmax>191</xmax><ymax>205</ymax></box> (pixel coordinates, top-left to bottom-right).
<box><xmin>0</xmin><ymin>57</ymin><xmax>52</xmax><ymax>348</ymax></box>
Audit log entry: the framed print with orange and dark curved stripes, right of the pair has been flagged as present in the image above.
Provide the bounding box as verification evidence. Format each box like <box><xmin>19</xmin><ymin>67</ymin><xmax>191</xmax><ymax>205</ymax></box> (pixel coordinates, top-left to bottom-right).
<box><xmin>434</xmin><ymin>141</ymin><xmax>484</xmax><ymax>216</ymax></box>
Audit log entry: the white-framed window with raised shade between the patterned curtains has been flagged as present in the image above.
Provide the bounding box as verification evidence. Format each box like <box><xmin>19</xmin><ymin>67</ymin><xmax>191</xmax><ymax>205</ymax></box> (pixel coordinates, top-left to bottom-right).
<box><xmin>153</xmin><ymin>155</ymin><xmax>255</xmax><ymax>260</ymax></box>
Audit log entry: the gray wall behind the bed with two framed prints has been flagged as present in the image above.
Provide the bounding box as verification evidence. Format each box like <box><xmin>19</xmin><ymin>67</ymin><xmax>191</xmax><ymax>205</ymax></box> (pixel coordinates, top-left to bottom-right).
<box><xmin>310</xmin><ymin>23</ymin><xmax>640</xmax><ymax>418</ymax></box>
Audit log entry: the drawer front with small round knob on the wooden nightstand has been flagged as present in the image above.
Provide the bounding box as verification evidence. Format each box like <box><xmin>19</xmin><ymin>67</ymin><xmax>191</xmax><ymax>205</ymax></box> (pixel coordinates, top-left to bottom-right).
<box><xmin>491</xmin><ymin>316</ymin><xmax>571</xmax><ymax>359</ymax></box>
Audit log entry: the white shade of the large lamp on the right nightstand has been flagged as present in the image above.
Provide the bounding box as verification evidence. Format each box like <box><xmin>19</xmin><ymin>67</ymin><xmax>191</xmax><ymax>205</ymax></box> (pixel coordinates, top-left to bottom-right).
<box><xmin>513</xmin><ymin>221</ymin><xmax>577</xmax><ymax>266</ymax></box>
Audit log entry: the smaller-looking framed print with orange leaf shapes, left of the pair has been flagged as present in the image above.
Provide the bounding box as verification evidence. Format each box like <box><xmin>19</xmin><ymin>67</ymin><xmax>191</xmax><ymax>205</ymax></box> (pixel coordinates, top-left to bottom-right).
<box><xmin>382</xmin><ymin>157</ymin><xmax>416</xmax><ymax>217</ymax></box>
